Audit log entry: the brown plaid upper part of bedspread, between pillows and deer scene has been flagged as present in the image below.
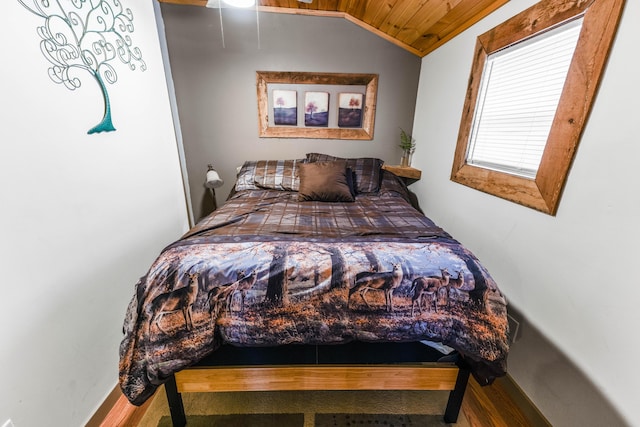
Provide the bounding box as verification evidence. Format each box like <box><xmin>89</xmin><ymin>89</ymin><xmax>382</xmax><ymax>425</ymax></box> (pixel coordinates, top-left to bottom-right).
<box><xmin>185</xmin><ymin>171</ymin><xmax>442</xmax><ymax>240</ymax></box>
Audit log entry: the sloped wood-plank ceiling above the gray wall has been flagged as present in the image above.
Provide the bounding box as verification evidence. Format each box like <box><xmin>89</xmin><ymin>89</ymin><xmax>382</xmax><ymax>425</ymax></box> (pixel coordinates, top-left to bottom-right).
<box><xmin>158</xmin><ymin>0</ymin><xmax>509</xmax><ymax>57</ymax></box>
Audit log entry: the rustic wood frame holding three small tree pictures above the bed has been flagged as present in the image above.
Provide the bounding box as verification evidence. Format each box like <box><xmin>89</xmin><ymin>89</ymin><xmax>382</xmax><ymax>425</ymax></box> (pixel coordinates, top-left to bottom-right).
<box><xmin>256</xmin><ymin>71</ymin><xmax>378</xmax><ymax>140</ymax></box>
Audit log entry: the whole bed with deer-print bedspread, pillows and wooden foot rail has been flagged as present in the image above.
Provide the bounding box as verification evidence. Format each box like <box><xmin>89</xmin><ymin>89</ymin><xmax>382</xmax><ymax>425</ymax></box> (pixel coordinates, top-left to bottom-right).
<box><xmin>119</xmin><ymin>153</ymin><xmax>508</xmax><ymax>426</ymax></box>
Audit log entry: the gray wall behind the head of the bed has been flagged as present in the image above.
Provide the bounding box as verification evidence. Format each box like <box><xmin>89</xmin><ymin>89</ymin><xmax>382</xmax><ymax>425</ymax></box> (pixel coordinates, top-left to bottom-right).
<box><xmin>162</xmin><ymin>4</ymin><xmax>421</xmax><ymax>220</ymax></box>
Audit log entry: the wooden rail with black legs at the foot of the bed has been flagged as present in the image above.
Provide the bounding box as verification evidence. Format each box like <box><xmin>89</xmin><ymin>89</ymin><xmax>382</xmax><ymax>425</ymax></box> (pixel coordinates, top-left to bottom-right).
<box><xmin>165</xmin><ymin>362</ymin><xmax>469</xmax><ymax>427</ymax></box>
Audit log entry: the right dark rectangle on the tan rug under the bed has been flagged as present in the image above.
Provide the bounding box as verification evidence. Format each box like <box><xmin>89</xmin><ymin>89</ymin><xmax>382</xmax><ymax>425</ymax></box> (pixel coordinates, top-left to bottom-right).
<box><xmin>315</xmin><ymin>414</ymin><xmax>449</xmax><ymax>427</ymax></box>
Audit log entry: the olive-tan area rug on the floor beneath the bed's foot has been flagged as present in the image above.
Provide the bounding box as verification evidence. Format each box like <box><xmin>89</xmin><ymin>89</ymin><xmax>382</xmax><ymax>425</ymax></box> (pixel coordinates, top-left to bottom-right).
<box><xmin>143</xmin><ymin>390</ymin><xmax>462</xmax><ymax>427</ymax></box>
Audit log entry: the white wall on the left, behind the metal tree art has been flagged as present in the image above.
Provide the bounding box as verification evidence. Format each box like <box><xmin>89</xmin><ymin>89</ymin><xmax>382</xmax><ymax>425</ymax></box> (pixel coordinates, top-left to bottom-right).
<box><xmin>0</xmin><ymin>0</ymin><xmax>187</xmax><ymax>427</ymax></box>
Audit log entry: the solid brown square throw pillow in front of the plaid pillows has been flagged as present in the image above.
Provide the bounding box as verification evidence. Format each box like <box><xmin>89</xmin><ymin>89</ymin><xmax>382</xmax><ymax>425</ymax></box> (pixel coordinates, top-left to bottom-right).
<box><xmin>298</xmin><ymin>161</ymin><xmax>355</xmax><ymax>202</ymax></box>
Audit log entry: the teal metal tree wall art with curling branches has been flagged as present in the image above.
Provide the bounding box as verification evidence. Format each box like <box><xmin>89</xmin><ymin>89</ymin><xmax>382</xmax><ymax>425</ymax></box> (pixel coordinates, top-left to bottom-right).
<box><xmin>18</xmin><ymin>0</ymin><xmax>147</xmax><ymax>134</ymax></box>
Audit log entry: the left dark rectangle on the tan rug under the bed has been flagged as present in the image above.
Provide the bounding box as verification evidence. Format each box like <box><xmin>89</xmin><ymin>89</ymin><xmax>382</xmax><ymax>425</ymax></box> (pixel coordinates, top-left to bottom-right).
<box><xmin>158</xmin><ymin>414</ymin><xmax>304</xmax><ymax>427</ymax></box>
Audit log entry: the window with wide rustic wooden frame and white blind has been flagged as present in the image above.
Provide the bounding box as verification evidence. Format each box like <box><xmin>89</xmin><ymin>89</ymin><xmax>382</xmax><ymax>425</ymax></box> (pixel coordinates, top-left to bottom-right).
<box><xmin>451</xmin><ymin>0</ymin><xmax>624</xmax><ymax>215</ymax></box>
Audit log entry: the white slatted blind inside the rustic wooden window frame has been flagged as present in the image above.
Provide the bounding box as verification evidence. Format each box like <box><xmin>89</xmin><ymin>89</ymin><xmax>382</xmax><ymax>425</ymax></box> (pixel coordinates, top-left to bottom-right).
<box><xmin>467</xmin><ymin>18</ymin><xmax>583</xmax><ymax>178</ymax></box>
